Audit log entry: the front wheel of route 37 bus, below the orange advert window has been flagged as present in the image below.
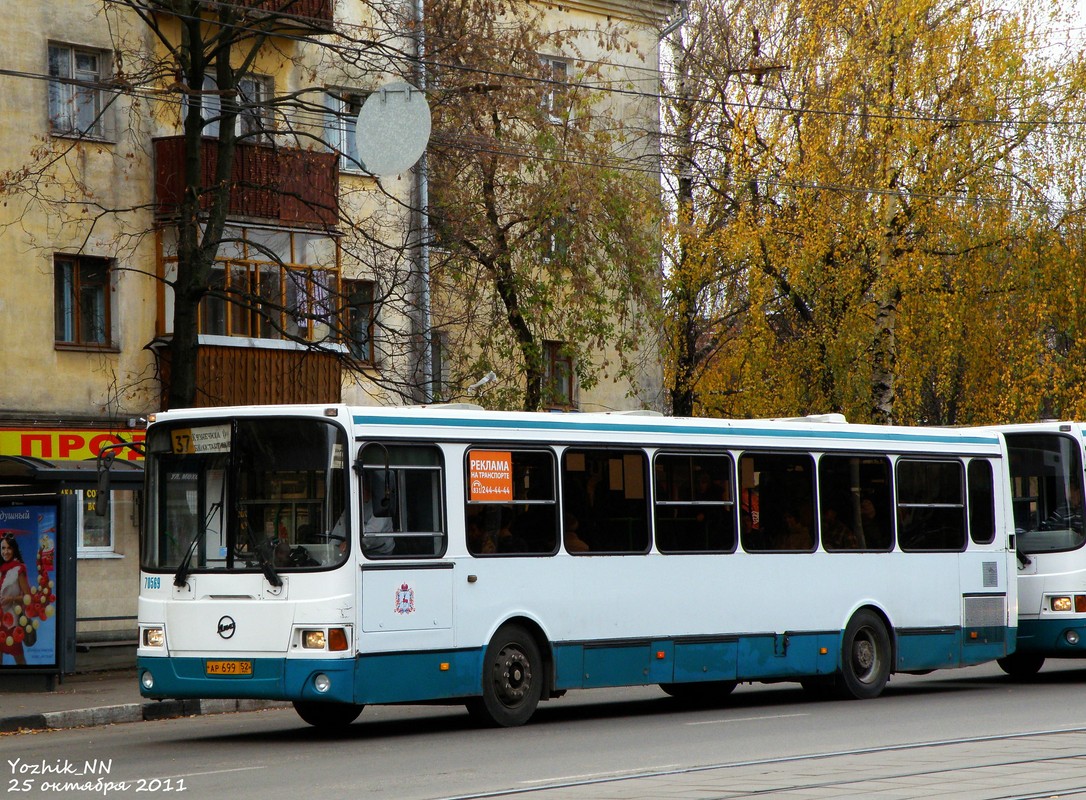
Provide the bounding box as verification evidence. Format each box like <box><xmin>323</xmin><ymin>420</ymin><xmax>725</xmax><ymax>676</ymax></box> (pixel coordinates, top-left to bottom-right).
<box><xmin>467</xmin><ymin>625</ymin><xmax>543</xmax><ymax>727</ymax></box>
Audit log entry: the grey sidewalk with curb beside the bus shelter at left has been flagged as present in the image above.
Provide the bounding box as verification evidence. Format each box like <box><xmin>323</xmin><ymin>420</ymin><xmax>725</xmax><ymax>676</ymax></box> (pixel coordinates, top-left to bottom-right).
<box><xmin>0</xmin><ymin>647</ymin><xmax>290</xmax><ymax>733</ymax></box>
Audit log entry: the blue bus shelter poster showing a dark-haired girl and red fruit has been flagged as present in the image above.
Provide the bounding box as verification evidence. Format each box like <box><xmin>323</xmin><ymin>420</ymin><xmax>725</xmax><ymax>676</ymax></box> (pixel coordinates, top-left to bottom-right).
<box><xmin>0</xmin><ymin>506</ymin><xmax>56</xmax><ymax>666</ymax></box>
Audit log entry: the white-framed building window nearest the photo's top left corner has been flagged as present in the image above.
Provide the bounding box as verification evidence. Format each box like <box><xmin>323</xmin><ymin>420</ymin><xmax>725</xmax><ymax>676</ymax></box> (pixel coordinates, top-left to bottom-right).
<box><xmin>49</xmin><ymin>45</ymin><xmax>109</xmax><ymax>139</ymax></box>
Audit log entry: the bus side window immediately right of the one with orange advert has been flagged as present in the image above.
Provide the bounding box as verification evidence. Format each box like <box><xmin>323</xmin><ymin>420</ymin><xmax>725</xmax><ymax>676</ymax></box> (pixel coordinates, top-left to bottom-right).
<box><xmin>561</xmin><ymin>448</ymin><xmax>649</xmax><ymax>555</ymax></box>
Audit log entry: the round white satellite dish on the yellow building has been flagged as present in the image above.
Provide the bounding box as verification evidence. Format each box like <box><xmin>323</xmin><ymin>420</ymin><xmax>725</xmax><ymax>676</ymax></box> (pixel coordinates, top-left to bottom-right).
<box><xmin>354</xmin><ymin>82</ymin><xmax>430</xmax><ymax>175</ymax></box>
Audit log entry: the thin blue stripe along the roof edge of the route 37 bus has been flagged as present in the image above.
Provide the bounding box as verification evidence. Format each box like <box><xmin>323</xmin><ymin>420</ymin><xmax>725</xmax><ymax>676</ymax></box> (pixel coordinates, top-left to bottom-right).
<box><xmin>353</xmin><ymin>415</ymin><xmax>999</xmax><ymax>445</ymax></box>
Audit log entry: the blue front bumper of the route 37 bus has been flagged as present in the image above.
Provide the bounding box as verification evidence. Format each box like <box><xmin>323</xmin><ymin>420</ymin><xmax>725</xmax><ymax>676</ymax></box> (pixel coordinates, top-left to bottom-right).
<box><xmin>136</xmin><ymin>656</ymin><xmax>354</xmax><ymax>702</ymax></box>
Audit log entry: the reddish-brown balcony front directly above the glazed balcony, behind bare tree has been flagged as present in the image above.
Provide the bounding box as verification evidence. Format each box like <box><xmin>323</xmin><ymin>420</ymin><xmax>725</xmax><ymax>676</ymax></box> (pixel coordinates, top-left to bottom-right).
<box><xmin>154</xmin><ymin>136</ymin><xmax>339</xmax><ymax>227</ymax></box>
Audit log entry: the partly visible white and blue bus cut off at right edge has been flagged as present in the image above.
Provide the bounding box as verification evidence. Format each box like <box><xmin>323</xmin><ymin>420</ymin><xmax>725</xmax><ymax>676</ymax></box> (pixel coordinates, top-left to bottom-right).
<box><xmin>999</xmin><ymin>422</ymin><xmax>1086</xmax><ymax>678</ymax></box>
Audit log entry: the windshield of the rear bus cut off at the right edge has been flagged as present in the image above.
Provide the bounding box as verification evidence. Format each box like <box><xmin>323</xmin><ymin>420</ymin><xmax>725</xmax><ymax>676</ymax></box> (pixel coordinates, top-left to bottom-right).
<box><xmin>1007</xmin><ymin>433</ymin><xmax>1086</xmax><ymax>554</ymax></box>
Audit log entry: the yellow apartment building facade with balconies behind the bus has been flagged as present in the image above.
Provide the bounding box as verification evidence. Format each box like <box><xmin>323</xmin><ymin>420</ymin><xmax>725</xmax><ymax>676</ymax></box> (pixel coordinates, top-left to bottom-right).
<box><xmin>0</xmin><ymin>0</ymin><xmax>672</xmax><ymax>640</ymax></box>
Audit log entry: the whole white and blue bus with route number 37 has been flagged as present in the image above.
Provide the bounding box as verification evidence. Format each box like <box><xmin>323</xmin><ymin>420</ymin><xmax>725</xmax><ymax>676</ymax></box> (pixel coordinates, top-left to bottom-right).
<box><xmin>138</xmin><ymin>405</ymin><xmax>1018</xmax><ymax>725</ymax></box>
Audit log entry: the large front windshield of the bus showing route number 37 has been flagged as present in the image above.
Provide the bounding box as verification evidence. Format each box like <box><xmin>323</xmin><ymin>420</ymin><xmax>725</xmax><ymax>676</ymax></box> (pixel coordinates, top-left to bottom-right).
<box><xmin>141</xmin><ymin>418</ymin><xmax>350</xmax><ymax>581</ymax></box>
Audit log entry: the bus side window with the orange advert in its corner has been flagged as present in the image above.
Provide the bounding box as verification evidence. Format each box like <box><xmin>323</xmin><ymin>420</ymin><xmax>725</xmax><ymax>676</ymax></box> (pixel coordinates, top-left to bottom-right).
<box><xmin>464</xmin><ymin>447</ymin><xmax>558</xmax><ymax>556</ymax></box>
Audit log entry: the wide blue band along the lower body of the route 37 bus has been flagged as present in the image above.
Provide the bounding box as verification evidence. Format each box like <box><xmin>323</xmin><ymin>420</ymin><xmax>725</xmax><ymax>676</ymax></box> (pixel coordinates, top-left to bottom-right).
<box><xmin>137</xmin><ymin>626</ymin><xmax>1016</xmax><ymax>704</ymax></box>
